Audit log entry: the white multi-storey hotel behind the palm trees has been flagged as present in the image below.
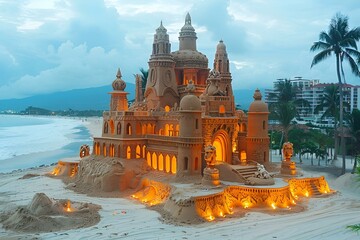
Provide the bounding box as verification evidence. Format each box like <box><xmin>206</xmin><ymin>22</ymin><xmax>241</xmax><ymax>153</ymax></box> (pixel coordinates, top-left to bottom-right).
<box><xmin>265</xmin><ymin>77</ymin><xmax>360</xmax><ymax>126</ymax></box>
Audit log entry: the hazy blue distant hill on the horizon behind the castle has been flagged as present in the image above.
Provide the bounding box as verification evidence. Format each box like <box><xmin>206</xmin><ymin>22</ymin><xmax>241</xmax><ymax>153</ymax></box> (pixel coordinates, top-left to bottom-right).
<box><xmin>0</xmin><ymin>83</ymin><xmax>258</xmax><ymax>111</ymax></box>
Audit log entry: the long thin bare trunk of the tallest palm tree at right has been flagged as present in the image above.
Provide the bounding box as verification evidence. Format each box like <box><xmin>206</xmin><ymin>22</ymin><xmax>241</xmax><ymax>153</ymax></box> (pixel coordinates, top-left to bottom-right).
<box><xmin>336</xmin><ymin>54</ymin><xmax>346</xmax><ymax>174</ymax></box>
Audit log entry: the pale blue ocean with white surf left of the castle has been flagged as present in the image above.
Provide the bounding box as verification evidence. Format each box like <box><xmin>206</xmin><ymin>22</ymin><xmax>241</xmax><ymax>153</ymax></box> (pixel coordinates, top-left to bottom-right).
<box><xmin>0</xmin><ymin>115</ymin><xmax>92</xmax><ymax>172</ymax></box>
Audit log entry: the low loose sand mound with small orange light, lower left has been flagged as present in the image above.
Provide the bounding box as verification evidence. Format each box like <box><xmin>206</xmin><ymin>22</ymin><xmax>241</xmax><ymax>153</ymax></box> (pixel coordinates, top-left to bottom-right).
<box><xmin>0</xmin><ymin>193</ymin><xmax>100</xmax><ymax>232</ymax></box>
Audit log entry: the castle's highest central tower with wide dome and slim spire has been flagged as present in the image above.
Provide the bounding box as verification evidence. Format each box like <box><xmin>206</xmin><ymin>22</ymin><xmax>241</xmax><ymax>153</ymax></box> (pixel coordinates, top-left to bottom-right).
<box><xmin>172</xmin><ymin>13</ymin><xmax>209</xmax><ymax>97</ymax></box>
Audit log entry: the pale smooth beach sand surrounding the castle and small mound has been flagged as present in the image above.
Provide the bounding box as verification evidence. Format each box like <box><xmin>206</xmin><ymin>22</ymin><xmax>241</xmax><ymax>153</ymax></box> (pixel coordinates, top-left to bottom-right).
<box><xmin>0</xmin><ymin>119</ymin><xmax>360</xmax><ymax>239</ymax></box>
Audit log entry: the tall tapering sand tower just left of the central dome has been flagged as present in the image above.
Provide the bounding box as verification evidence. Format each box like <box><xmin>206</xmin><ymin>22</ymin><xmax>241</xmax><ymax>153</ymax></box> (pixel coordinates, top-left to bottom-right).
<box><xmin>144</xmin><ymin>22</ymin><xmax>179</xmax><ymax>109</ymax></box>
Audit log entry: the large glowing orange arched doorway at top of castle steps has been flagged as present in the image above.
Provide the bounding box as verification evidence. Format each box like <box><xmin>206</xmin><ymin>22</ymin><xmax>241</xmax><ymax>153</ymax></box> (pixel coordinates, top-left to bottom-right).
<box><xmin>212</xmin><ymin>130</ymin><xmax>231</xmax><ymax>163</ymax></box>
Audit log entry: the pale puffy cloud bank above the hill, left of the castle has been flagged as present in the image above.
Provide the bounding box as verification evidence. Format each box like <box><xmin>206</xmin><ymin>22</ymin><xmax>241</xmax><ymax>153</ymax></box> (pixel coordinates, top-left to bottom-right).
<box><xmin>0</xmin><ymin>41</ymin><xmax>119</xmax><ymax>99</ymax></box>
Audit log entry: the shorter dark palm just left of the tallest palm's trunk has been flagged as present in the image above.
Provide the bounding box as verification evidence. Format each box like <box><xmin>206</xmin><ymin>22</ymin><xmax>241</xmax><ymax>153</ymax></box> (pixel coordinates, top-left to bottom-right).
<box><xmin>314</xmin><ymin>84</ymin><xmax>340</xmax><ymax>160</ymax></box>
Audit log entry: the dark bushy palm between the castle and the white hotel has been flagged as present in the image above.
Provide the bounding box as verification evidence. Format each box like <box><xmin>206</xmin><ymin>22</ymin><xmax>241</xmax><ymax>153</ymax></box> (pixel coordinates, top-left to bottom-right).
<box><xmin>269</xmin><ymin>79</ymin><xmax>309</xmax><ymax>144</ymax></box>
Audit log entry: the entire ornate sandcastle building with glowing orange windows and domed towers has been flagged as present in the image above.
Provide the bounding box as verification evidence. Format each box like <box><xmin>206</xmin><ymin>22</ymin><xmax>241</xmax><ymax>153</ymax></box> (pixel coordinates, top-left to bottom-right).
<box><xmin>93</xmin><ymin>14</ymin><xmax>269</xmax><ymax>176</ymax></box>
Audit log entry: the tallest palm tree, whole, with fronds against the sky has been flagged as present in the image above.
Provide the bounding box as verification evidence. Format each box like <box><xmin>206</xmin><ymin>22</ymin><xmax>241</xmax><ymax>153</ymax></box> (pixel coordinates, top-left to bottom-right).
<box><xmin>310</xmin><ymin>13</ymin><xmax>360</xmax><ymax>174</ymax></box>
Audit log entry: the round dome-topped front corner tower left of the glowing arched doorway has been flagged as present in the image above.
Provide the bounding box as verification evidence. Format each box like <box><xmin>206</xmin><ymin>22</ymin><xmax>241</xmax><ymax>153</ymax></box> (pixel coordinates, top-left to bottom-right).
<box><xmin>177</xmin><ymin>81</ymin><xmax>203</xmax><ymax>176</ymax></box>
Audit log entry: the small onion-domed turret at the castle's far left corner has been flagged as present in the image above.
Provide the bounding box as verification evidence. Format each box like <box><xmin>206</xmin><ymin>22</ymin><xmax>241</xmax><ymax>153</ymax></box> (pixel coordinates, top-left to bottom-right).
<box><xmin>109</xmin><ymin>68</ymin><xmax>128</xmax><ymax>111</ymax></box>
